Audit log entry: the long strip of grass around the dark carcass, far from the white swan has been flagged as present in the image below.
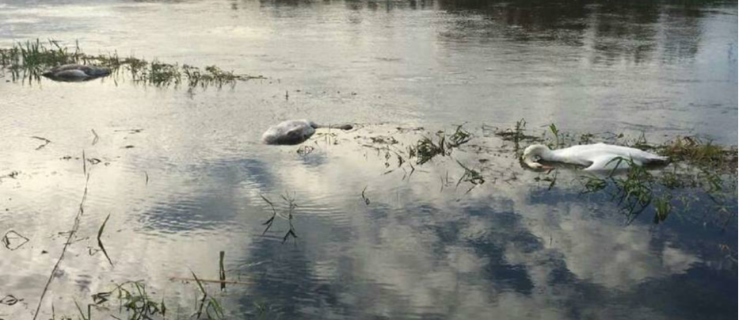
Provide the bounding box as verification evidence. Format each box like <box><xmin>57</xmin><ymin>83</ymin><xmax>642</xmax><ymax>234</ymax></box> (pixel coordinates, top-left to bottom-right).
<box><xmin>0</xmin><ymin>40</ymin><xmax>264</xmax><ymax>87</ymax></box>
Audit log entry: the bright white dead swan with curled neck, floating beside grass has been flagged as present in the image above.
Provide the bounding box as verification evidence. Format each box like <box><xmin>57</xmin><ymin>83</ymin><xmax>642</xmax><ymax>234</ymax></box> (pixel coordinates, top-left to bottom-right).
<box><xmin>523</xmin><ymin>143</ymin><xmax>669</xmax><ymax>171</ymax></box>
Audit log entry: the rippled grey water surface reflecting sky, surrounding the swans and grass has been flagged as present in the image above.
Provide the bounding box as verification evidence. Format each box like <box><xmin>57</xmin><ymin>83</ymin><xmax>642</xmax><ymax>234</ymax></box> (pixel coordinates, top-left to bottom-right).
<box><xmin>0</xmin><ymin>1</ymin><xmax>739</xmax><ymax>319</ymax></box>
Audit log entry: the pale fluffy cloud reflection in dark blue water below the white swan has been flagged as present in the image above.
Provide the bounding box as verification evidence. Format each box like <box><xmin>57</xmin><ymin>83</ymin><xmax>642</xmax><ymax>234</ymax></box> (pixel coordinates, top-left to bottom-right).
<box><xmin>506</xmin><ymin>203</ymin><xmax>698</xmax><ymax>288</ymax></box>
